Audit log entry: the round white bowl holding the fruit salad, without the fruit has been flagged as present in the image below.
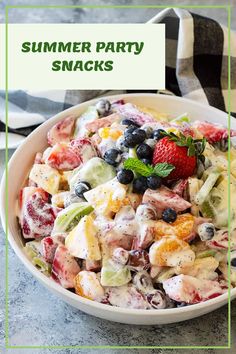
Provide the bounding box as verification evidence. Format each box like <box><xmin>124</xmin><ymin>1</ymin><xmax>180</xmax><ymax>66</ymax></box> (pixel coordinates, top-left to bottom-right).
<box><xmin>0</xmin><ymin>94</ymin><xmax>236</xmax><ymax>325</ymax></box>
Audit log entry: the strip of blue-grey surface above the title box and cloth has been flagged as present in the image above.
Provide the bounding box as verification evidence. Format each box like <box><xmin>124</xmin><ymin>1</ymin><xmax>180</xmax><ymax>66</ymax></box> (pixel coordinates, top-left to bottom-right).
<box><xmin>0</xmin><ymin>0</ymin><xmax>236</xmax><ymax>29</ymax></box>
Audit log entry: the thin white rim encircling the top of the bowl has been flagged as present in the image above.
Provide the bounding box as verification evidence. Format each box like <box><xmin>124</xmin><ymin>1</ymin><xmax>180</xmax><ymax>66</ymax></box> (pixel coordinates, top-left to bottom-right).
<box><xmin>0</xmin><ymin>93</ymin><xmax>236</xmax><ymax>317</ymax></box>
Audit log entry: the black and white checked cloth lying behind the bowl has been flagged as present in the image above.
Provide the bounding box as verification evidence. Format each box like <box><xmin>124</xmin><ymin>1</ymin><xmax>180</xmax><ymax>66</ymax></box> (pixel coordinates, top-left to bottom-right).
<box><xmin>0</xmin><ymin>9</ymin><xmax>236</xmax><ymax>146</ymax></box>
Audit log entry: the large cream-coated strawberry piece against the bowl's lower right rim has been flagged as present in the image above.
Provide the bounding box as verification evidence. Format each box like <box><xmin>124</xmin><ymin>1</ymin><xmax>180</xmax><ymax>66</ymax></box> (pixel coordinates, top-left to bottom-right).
<box><xmin>163</xmin><ymin>274</ymin><xmax>227</xmax><ymax>304</ymax></box>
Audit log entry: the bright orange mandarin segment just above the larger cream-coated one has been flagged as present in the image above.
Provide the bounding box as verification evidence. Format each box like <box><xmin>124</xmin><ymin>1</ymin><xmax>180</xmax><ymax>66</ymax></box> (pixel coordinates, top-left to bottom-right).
<box><xmin>155</xmin><ymin>213</ymin><xmax>195</xmax><ymax>240</ymax></box>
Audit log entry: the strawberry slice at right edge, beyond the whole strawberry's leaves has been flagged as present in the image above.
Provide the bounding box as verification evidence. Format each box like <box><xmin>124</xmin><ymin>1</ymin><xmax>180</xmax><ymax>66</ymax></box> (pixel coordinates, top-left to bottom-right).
<box><xmin>193</xmin><ymin>121</ymin><xmax>236</xmax><ymax>144</ymax></box>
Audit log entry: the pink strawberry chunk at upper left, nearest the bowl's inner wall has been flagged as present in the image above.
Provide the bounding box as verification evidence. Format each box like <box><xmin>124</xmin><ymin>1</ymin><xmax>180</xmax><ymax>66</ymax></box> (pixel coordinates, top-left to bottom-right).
<box><xmin>48</xmin><ymin>116</ymin><xmax>75</xmax><ymax>146</ymax></box>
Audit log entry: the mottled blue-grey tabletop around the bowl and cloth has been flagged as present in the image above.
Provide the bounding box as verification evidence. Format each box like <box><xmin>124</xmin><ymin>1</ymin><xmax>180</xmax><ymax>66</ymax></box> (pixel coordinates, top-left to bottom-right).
<box><xmin>0</xmin><ymin>0</ymin><xmax>236</xmax><ymax>354</ymax></box>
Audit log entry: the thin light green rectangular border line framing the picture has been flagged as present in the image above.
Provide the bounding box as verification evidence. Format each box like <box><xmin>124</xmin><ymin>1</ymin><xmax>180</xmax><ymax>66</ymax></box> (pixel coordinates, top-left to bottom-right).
<box><xmin>5</xmin><ymin>5</ymin><xmax>232</xmax><ymax>349</ymax></box>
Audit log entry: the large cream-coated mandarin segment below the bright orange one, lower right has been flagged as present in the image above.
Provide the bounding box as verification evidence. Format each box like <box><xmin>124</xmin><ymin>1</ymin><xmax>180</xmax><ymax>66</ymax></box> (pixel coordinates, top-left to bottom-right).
<box><xmin>149</xmin><ymin>236</ymin><xmax>195</xmax><ymax>267</ymax></box>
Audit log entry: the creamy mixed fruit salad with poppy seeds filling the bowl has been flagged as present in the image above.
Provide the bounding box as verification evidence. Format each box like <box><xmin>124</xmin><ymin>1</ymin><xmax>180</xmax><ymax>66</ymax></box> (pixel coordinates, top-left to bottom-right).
<box><xmin>18</xmin><ymin>99</ymin><xmax>236</xmax><ymax>310</ymax></box>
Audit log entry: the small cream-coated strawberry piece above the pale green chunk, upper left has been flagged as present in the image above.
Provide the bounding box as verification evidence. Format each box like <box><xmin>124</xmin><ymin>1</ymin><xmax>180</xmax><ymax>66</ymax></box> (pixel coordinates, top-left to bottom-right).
<box><xmin>70</xmin><ymin>138</ymin><xmax>97</xmax><ymax>163</ymax></box>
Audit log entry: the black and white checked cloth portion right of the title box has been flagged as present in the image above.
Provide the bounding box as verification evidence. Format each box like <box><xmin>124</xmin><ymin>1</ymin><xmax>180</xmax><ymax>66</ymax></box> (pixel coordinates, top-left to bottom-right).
<box><xmin>150</xmin><ymin>9</ymin><xmax>236</xmax><ymax>115</ymax></box>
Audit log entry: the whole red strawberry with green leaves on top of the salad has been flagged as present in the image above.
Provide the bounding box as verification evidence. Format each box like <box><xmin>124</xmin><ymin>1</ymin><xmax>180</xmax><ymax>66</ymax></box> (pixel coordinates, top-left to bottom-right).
<box><xmin>152</xmin><ymin>133</ymin><xmax>205</xmax><ymax>181</ymax></box>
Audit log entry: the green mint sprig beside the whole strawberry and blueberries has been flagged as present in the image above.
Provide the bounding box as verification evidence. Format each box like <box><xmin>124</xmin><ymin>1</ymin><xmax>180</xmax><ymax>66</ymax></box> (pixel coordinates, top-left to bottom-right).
<box><xmin>124</xmin><ymin>157</ymin><xmax>175</xmax><ymax>178</ymax></box>
